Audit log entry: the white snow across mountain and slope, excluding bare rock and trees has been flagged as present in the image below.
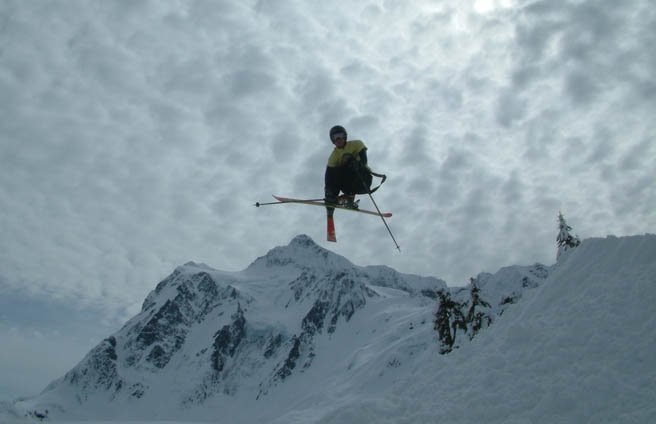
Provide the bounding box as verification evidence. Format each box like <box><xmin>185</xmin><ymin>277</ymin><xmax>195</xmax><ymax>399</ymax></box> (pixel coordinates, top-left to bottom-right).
<box><xmin>5</xmin><ymin>234</ymin><xmax>656</xmax><ymax>424</ymax></box>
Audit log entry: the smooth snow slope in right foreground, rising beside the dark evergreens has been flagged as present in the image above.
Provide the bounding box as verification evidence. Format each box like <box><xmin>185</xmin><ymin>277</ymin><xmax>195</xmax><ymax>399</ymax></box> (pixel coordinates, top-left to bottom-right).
<box><xmin>314</xmin><ymin>235</ymin><xmax>656</xmax><ymax>424</ymax></box>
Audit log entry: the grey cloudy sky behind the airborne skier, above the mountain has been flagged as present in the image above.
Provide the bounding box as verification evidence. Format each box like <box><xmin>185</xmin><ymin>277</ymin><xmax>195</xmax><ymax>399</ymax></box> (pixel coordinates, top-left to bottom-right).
<box><xmin>0</xmin><ymin>0</ymin><xmax>656</xmax><ymax>399</ymax></box>
